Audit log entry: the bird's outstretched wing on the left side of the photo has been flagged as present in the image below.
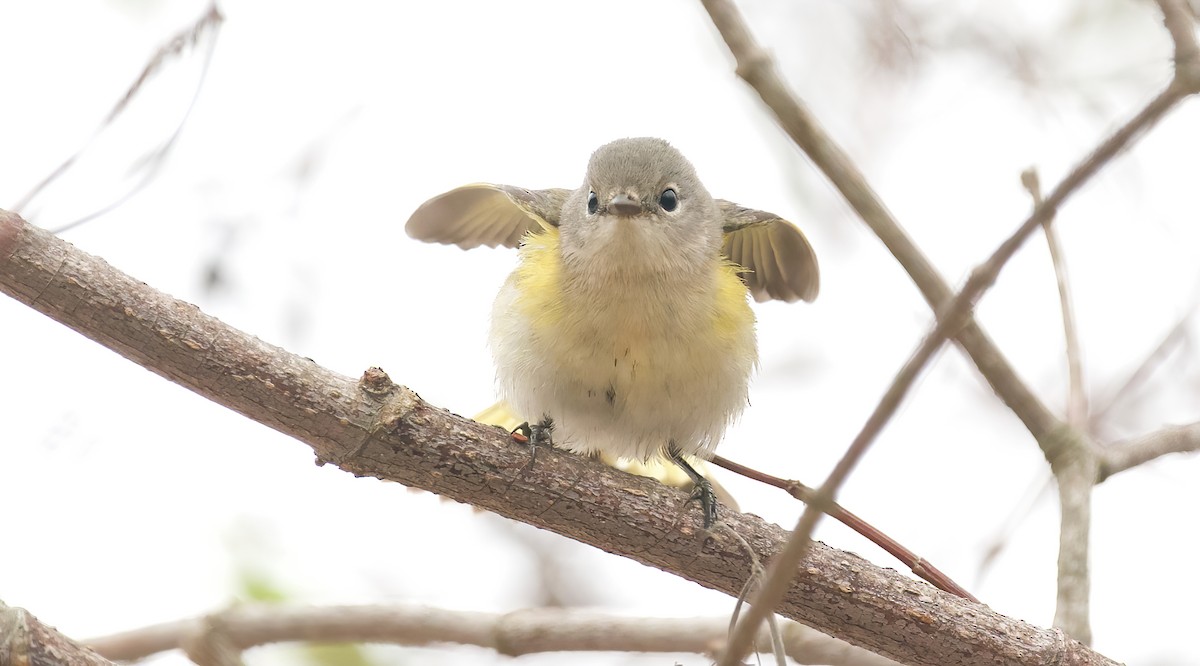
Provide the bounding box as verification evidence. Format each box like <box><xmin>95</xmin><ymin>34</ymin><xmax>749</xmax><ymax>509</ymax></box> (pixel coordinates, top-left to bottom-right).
<box><xmin>404</xmin><ymin>182</ymin><xmax>571</xmax><ymax>250</ymax></box>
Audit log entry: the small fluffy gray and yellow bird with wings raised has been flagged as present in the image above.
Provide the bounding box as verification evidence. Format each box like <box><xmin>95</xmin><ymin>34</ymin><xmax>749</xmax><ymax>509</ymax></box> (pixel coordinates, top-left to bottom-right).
<box><xmin>406</xmin><ymin>137</ymin><xmax>820</xmax><ymax>528</ymax></box>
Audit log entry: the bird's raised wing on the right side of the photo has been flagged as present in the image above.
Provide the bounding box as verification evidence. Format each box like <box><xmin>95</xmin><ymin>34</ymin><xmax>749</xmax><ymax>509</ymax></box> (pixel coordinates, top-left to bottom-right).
<box><xmin>716</xmin><ymin>199</ymin><xmax>821</xmax><ymax>302</ymax></box>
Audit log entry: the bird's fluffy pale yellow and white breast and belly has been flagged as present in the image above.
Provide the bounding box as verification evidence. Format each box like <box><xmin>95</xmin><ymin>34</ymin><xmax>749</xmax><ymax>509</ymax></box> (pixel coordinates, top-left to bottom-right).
<box><xmin>491</xmin><ymin>268</ymin><xmax>756</xmax><ymax>458</ymax></box>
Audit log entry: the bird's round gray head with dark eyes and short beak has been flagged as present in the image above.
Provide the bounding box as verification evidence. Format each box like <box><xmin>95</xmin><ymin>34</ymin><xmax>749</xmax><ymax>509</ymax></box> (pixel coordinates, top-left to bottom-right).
<box><xmin>559</xmin><ymin>138</ymin><xmax>721</xmax><ymax>274</ymax></box>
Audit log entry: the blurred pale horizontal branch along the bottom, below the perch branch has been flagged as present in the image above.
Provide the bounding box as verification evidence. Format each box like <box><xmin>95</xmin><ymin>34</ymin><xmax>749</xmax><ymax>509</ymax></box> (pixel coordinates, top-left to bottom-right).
<box><xmin>84</xmin><ymin>605</ymin><xmax>898</xmax><ymax>666</ymax></box>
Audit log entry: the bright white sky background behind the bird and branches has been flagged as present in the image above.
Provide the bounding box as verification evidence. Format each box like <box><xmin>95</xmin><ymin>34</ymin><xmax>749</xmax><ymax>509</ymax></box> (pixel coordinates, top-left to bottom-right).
<box><xmin>0</xmin><ymin>0</ymin><xmax>1200</xmax><ymax>664</ymax></box>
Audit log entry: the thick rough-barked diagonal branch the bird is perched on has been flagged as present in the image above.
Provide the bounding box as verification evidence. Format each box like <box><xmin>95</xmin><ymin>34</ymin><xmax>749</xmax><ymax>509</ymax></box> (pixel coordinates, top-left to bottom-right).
<box><xmin>0</xmin><ymin>212</ymin><xmax>1111</xmax><ymax>666</ymax></box>
